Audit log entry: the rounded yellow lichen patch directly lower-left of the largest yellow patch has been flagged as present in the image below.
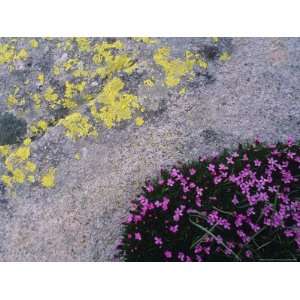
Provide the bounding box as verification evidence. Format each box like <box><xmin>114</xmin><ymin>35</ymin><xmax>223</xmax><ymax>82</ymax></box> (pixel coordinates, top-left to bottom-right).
<box><xmin>59</xmin><ymin>112</ymin><xmax>96</xmax><ymax>140</ymax></box>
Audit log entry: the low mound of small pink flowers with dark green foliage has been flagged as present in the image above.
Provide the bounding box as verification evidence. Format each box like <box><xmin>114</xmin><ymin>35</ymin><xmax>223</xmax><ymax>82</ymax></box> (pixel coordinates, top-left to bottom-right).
<box><xmin>123</xmin><ymin>138</ymin><xmax>300</xmax><ymax>261</ymax></box>
